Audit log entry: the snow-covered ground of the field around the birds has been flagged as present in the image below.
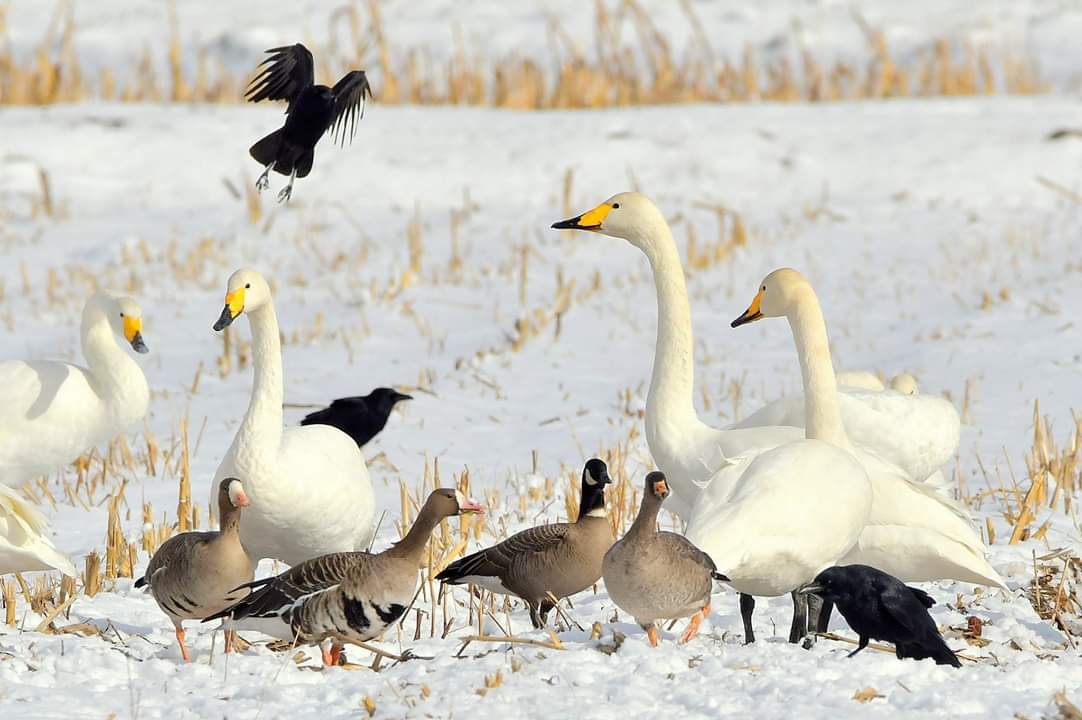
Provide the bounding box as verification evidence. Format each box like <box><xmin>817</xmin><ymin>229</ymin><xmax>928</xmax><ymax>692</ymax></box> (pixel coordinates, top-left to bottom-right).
<box><xmin>0</xmin><ymin>0</ymin><xmax>1082</xmax><ymax>718</ymax></box>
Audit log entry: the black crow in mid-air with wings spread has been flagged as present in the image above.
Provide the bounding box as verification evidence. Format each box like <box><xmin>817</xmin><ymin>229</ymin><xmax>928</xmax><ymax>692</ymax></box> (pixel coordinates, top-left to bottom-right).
<box><xmin>245</xmin><ymin>43</ymin><xmax>372</xmax><ymax>202</ymax></box>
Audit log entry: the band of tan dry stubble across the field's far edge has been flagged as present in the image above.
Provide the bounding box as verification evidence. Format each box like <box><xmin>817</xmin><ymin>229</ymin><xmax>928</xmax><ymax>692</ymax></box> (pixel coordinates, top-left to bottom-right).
<box><xmin>0</xmin><ymin>0</ymin><xmax>1051</xmax><ymax>108</ymax></box>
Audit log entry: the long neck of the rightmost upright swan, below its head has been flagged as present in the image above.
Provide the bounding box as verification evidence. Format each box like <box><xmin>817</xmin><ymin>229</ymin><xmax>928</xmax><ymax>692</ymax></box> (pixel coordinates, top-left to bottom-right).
<box><xmin>787</xmin><ymin>287</ymin><xmax>850</xmax><ymax>448</ymax></box>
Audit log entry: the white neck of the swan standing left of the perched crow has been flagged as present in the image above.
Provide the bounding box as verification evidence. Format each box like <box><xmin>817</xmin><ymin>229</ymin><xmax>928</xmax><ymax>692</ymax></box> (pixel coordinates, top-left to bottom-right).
<box><xmin>237</xmin><ymin>301</ymin><xmax>282</xmax><ymax>461</ymax></box>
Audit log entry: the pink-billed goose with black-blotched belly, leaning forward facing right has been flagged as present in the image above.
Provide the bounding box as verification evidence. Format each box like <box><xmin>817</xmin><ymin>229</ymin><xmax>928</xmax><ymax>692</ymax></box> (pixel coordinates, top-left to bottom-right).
<box><xmin>204</xmin><ymin>488</ymin><xmax>484</xmax><ymax>665</ymax></box>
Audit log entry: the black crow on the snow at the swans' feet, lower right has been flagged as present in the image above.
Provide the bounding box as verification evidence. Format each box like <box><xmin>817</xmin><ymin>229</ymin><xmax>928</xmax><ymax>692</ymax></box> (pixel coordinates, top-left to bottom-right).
<box><xmin>799</xmin><ymin>565</ymin><xmax>962</xmax><ymax>667</ymax></box>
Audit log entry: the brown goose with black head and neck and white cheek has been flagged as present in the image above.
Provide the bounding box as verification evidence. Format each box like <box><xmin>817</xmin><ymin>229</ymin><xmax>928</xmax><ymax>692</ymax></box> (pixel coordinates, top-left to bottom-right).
<box><xmin>436</xmin><ymin>458</ymin><xmax>616</xmax><ymax>628</ymax></box>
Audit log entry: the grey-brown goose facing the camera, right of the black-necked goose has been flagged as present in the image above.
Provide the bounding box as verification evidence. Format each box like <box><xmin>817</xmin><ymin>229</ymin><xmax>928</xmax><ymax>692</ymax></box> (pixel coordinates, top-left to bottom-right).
<box><xmin>602</xmin><ymin>471</ymin><xmax>729</xmax><ymax>647</ymax></box>
